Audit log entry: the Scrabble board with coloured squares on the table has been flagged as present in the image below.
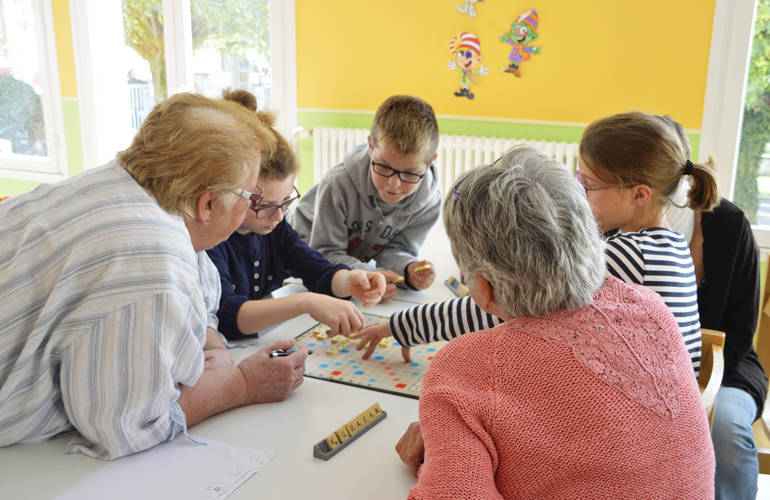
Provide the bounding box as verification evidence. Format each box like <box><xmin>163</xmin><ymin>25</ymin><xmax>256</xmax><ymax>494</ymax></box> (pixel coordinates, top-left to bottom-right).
<box><xmin>294</xmin><ymin>314</ymin><xmax>446</xmax><ymax>399</ymax></box>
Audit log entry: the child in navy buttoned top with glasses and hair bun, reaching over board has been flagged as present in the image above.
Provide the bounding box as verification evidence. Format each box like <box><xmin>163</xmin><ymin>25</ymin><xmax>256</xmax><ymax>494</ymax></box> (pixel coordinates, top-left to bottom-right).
<box><xmin>208</xmin><ymin>90</ymin><xmax>385</xmax><ymax>339</ymax></box>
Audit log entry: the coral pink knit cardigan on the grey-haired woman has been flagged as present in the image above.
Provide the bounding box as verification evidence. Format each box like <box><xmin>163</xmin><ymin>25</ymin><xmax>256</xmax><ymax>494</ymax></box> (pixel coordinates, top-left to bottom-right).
<box><xmin>409</xmin><ymin>277</ymin><xmax>714</xmax><ymax>499</ymax></box>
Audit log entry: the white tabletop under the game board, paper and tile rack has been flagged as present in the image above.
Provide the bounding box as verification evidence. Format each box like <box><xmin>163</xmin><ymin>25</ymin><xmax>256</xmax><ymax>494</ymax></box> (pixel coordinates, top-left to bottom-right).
<box><xmin>0</xmin><ymin>224</ymin><xmax>457</xmax><ymax>500</ymax></box>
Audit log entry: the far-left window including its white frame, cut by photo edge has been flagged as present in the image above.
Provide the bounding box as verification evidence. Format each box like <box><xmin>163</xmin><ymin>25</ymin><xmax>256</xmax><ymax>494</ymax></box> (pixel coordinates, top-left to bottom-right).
<box><xmin>0</xmin><ymin>0</ymin><xmax>66</xmax><ymax>181</ymax></box>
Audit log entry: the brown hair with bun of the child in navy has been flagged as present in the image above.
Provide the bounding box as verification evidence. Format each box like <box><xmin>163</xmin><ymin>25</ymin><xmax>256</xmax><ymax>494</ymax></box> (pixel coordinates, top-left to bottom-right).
<box><xmin>222</xmin><ymin>89</ymin><xmax>299</xmax><ymax>181</ymax></box>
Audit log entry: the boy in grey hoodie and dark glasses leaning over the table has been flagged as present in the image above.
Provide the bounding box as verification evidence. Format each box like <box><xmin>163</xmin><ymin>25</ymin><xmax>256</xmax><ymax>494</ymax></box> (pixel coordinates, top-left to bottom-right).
<box><xmin>290</xmin><ymin>95</ymin><xmax>441</xmax><ymax>301</ymax></box>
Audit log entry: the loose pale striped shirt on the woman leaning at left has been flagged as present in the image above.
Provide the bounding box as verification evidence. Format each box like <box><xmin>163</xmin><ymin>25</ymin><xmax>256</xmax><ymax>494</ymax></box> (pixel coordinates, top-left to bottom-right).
<box><xmin>0</xmin><ymin>162</ymin><xmax>210</xmax><ymax>459</ymax></box>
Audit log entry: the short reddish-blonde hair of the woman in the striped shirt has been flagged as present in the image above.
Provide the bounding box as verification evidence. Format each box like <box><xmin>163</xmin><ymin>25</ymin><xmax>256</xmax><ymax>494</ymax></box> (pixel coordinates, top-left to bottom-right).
<box><xmin>116</xmin><ymin>93</ymin><xmax>275</xmax><ymax>217</ymax></box>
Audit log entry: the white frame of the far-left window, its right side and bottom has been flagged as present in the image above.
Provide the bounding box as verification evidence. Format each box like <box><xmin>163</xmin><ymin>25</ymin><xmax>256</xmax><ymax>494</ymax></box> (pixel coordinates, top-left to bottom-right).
<box><xmin>0</xmin><ymin>0</ymin><xmax>67</xmax><ymax>182</ymax></box>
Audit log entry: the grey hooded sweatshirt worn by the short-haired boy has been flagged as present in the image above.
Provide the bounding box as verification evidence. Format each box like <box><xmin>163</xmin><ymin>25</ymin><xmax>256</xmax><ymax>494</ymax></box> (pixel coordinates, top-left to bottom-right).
<box><xmin>289</xmin><ymin>145</ymin><xmax>441</xmax><ymax>274</ymax></box>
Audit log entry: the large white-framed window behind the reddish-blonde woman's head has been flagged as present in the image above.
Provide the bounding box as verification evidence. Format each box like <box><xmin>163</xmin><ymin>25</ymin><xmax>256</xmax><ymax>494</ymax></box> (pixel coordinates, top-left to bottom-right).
<box><xmin>70</xmin><ymin>0</ymin><xmax>296</xmax><ymax>172</ymax></box>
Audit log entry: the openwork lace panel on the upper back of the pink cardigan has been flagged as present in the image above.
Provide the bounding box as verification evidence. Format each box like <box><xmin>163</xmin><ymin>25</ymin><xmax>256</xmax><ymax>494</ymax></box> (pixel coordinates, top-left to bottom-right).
<box><xmin>514</xmin><ymin>278</ymin><xmax>680</xmax><ymax>417</ymax></box>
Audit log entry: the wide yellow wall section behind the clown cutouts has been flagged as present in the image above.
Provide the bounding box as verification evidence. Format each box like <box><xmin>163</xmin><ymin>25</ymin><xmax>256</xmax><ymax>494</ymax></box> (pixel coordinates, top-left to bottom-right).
<box><xmin>296</xmin><ymin>0</ymin><xmax>715</xmax><ymax>129</ymax></box>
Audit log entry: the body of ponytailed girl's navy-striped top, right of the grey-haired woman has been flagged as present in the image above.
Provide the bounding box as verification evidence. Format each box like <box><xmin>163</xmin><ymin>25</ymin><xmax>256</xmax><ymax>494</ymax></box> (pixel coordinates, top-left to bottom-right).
<box><xmin>605</xmin><ymin>227</ymin><xmax>701</xmax><ymax>376</ymax></box>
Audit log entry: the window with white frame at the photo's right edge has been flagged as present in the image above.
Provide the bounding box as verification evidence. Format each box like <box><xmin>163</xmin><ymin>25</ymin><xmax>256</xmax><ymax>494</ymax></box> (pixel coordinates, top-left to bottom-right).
<box><xmin>699</xmin><ymin>0</ymin><xmax>770</xmax><ymax>249</ymax></box>
